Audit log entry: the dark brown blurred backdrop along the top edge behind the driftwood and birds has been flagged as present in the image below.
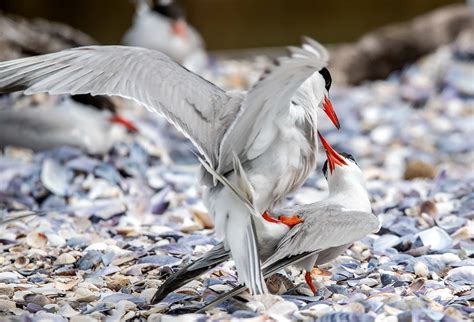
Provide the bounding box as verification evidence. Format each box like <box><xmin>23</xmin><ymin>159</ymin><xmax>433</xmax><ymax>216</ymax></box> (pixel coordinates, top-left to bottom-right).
<box><xmin>0</xmin><ymin>0</ymin><xmax>465</xmax><ymax>50</ymax></box>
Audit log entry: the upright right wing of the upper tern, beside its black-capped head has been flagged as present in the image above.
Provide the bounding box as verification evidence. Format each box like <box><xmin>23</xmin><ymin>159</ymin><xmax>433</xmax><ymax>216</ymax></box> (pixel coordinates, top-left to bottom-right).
<box><xmin>218</xmin><ymin>38</ymin><xmax>329</xmax><ymax>173</ymax></box>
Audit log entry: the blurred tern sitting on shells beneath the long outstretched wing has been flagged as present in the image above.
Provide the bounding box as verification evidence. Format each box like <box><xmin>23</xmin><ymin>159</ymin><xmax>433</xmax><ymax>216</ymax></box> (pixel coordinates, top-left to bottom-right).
<box><xmin>0</xmin><ymin>98</ymin><xmax>137</xmax><ymax>154</ymax></box>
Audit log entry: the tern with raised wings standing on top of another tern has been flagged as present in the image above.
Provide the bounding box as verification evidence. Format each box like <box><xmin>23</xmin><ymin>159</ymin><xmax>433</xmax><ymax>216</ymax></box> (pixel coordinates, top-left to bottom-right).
<box><xmin>0</xmin><ymin>38</ymin><xmax>339</xmax><ymax>294</ymax></box>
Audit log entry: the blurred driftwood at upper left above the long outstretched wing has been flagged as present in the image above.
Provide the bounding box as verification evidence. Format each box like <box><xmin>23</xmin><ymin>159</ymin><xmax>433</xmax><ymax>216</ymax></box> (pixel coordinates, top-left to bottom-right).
<box><xmin>0</xmin><ymin>12</ymin><xmax>96</xmax><ymax>61</ymax></box>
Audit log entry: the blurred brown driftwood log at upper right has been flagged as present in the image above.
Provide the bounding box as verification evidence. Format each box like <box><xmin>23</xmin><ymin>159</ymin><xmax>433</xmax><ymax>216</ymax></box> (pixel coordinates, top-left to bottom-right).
<box><xmin>331</xmin><ymin>5</ymin><xmax>474</xmax><ymax>85</ymax></box>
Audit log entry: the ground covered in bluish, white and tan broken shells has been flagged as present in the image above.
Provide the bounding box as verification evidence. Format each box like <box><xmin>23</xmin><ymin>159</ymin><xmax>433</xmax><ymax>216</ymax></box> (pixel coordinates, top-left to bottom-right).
<box><xmin>0</xmin><ymin>41</ymin><xmax>474</xmax><ymax>321</ymax></box>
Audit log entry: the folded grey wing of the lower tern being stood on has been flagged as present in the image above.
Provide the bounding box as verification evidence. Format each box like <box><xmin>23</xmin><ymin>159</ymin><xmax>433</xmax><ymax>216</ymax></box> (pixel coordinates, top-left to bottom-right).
<box><xmin>263</xmin><ymin>205</ymin><xmax>380</xmax><ymax>268</ymax></box>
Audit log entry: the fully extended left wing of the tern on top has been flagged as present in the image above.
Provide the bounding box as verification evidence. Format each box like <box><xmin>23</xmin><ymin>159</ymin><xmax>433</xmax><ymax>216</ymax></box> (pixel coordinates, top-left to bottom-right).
<box><xmin>0</xmin><ymin>46</ymin><xmax>233</xmax><ymax>165</ymax></box>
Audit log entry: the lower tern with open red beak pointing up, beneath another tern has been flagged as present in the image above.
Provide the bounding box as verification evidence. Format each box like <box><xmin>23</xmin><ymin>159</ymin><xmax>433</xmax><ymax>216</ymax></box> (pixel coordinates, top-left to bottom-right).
<box><xmin>195</xmin><ymin>135</ymin><xmax>380</xmax><ymax>312</ymax></box>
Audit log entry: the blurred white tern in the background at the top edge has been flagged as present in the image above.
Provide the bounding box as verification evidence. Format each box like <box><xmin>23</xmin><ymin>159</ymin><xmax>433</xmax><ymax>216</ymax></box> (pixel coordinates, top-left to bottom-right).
<box><xmin>122</xmin><ymin>0</ymin><xmax>208</xmax><ymax>73</ymax></box>
